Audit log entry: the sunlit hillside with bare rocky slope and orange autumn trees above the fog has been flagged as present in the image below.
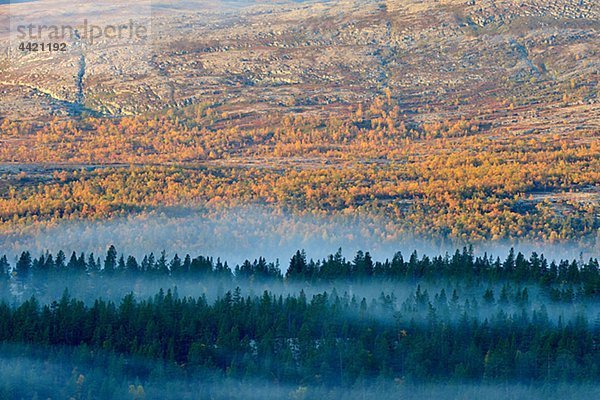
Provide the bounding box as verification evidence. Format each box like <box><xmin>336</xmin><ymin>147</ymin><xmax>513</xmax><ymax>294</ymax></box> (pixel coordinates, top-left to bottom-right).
<box><xmin>0</xmin><ymin>0</ymin><xmax>600</xmax><ymax>245</ymax></box>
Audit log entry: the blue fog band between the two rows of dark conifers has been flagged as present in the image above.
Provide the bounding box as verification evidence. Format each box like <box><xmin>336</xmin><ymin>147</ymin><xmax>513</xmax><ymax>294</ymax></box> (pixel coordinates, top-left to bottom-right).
<box><xmin>0</xmin><ymin>274</ymin><xmax>600</xmax><ymax>324</ymax></box>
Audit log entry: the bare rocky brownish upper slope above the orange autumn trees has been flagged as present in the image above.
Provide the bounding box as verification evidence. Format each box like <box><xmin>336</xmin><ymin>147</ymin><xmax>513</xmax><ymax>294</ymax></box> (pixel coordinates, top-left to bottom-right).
<box><xmin>0</xmin><ymin>0</ymin><xmax>600</xmax><ymax>130</ymax></box>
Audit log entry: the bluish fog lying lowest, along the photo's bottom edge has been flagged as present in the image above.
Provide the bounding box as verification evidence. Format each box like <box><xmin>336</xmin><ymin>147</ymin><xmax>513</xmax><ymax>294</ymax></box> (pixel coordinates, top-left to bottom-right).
<box><xmin>0</xmin><ymin>345</ymin><xmax>600</xmax><ymax>400</ymax></box>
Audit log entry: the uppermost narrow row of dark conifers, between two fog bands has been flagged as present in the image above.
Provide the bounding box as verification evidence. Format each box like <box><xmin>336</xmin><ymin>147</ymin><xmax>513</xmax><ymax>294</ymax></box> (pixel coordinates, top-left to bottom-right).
<box><xmin>0</xmin><ymin>246</ymin><xmax>600</xmax><ymax>299</ymax></box>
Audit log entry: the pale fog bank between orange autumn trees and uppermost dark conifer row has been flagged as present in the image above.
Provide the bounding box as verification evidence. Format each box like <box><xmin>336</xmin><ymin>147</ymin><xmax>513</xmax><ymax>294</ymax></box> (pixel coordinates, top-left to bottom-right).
<box><xmin>0</xmin><ymin>206</ymin><xmax>600</xmax><ymax>265</ymax></box>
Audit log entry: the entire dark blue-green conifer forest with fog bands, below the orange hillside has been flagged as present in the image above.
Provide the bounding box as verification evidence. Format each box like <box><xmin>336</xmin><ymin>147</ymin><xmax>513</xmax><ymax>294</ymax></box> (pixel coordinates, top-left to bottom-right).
<box><xmin>0</xmin><ymin>246</ymin><xmax>600</xmax><ymax>399</ymax></box>
